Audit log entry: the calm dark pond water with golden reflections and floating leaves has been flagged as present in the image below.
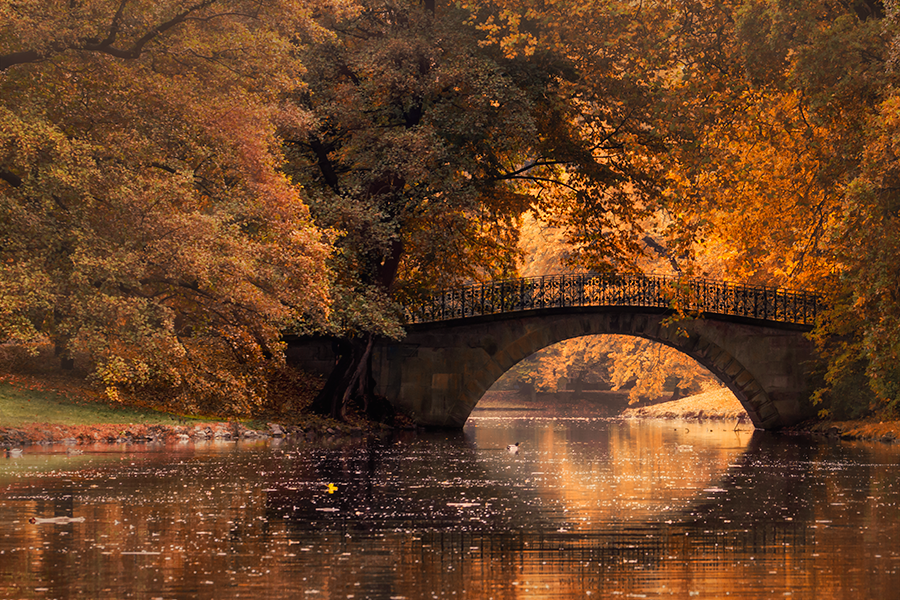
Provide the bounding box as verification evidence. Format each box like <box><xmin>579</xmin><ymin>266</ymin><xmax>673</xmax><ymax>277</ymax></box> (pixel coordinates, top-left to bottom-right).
<box><xmin>0</xmin><ymin>413</ymin><xmax>900</xmax><ymax>600</ymax></box>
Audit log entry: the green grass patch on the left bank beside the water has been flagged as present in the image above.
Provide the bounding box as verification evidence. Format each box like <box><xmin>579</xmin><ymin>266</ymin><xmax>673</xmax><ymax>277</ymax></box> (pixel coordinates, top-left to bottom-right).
<box><xmin>0</xmin><ymin>383</ymin><xmax>200</xmax><ymax>427</ymax></box>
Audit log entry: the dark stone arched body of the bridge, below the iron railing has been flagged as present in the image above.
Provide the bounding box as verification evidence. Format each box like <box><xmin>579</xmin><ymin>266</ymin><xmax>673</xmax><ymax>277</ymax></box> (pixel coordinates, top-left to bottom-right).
<box><xmin>375</xmin><ymin>307</ymin><xmax>813</xmax><ymax>429</ymax></box>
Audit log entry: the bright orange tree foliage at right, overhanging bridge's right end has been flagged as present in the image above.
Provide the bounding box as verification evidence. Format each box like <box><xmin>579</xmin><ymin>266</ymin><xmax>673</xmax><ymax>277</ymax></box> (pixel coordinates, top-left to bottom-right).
<box><xmin>648</xmin><ymin>0</ymin><xmax>900</xmax><ymax>415</ymax></box>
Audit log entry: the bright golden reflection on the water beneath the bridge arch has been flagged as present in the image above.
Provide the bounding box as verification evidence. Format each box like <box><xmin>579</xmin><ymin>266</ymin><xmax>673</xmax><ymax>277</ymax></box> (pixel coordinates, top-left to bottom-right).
<box><xmin>475</xmin><ymin>420</ymin><xmax>749</xmax><ymax>530</ymax></box>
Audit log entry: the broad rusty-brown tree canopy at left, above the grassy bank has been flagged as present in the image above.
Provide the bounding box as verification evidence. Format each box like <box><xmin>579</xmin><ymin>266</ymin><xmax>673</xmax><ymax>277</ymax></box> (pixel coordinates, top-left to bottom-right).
<box><xmin>0</xmin><ymin>0</ymin><xmax>329</xmax><ymax>412</ymax></box>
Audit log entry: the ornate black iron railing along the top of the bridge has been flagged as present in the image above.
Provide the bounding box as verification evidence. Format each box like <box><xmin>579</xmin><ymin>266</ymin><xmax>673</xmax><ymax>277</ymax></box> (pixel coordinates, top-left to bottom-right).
<box><xmin>406</xmin><ymin>273</ymin><xmax>822</xmax><ymax>325</ymax></box>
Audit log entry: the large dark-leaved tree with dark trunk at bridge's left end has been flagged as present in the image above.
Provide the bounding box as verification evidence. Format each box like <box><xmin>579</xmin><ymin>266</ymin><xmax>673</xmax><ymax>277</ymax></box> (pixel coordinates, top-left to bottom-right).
<box><xmin>285</xmin><ymin>0</ymin><xmax>680</xmax><ymax>415</ymax></box>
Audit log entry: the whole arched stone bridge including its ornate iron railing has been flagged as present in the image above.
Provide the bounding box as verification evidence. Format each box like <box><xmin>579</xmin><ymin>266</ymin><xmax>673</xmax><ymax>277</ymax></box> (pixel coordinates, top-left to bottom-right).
<box><xmin>294</xmin><ymin>274</ymin><xmax>821</xmax><ymax>429</ymax></box>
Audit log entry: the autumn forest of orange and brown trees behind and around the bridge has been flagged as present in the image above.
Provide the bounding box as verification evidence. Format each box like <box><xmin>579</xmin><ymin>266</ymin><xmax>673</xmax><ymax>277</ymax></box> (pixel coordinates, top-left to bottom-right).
<box><xmin>0</xmin><ymin>0</ymin><xmax>900</xmax><ymax>416</ymax></box>
